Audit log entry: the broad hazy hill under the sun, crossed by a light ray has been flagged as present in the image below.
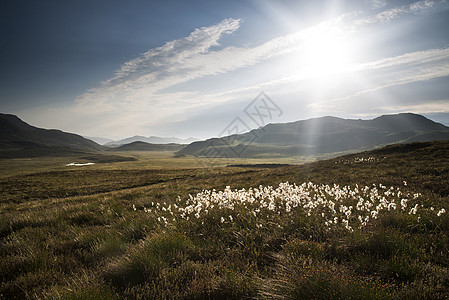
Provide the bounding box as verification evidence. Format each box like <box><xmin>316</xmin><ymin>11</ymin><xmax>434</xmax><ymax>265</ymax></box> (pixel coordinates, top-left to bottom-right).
<box><xmin>178</xmin><ymin>113</ymin><xmax>449</xmax><ymax>157</ymax></box>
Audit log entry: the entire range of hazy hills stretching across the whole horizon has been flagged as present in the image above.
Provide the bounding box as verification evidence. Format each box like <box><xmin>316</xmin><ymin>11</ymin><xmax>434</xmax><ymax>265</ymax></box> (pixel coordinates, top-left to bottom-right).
<box><xmin>0</xmin><ymin>113</ymin><xmax>449</xmax><ymax>159</ymax></box>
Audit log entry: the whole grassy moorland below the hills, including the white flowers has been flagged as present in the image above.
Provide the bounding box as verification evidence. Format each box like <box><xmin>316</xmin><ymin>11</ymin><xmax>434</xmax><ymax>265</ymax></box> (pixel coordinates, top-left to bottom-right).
<box><xmin>0</xmin><ymin>142</ymin><xmax>449</xmax><ymax>299</ymax></box>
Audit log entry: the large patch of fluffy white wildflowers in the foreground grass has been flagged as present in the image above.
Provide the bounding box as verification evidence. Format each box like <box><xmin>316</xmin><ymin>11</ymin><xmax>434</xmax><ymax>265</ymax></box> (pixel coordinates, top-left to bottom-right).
<box><xmin>133</xmin><ymin>182</ymin><xmax>446</xmax><ymax>232</ymax></box>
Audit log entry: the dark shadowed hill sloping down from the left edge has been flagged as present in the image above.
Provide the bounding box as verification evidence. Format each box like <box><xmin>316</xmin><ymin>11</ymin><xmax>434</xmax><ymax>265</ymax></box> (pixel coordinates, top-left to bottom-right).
<box><xmin>0</xmin><ymin>113</ymin><xmax>104</xmax><ymax>158</ymax></box>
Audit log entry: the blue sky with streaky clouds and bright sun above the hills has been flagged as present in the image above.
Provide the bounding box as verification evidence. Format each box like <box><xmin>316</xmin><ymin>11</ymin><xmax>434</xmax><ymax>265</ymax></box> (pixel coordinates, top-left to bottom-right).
<box><xmin>0</xmin><ymin>0</ymin><xmax>449</xmax><ymax>139</ymax></box>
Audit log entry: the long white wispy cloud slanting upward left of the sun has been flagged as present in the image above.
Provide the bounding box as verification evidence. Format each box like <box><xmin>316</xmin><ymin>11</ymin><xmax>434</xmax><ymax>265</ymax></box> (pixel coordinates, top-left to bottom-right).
<box><xmin>76</xmin><ymin>19</ymin><xmax>241</xmax><ymax>110</ymax></box>
